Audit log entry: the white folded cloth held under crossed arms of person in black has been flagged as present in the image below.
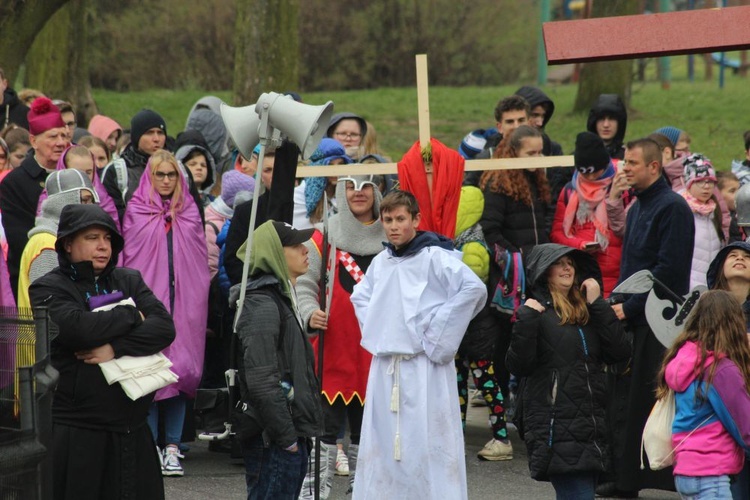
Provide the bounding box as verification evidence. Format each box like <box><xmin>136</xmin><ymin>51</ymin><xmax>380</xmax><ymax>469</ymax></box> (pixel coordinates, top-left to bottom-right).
<box><xmin>92</xmin><ymin>298</ymin><xmax>178</xmax><ymax>401</ymax></box>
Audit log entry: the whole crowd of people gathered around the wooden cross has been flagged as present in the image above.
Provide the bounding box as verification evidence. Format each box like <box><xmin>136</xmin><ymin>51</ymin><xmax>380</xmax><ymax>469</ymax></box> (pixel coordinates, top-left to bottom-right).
<box><xmin>0</xmin><ymin>62</ymin><xmax>750</xmax><ymax>499</ymax></box>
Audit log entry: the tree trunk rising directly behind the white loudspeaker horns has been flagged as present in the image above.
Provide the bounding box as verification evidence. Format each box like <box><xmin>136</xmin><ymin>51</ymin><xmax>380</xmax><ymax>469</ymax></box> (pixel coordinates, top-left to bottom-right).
<box><xmin>232</xmin><ymin>0</ymin><xmax>299</xmax><ymax>105</ymax></box>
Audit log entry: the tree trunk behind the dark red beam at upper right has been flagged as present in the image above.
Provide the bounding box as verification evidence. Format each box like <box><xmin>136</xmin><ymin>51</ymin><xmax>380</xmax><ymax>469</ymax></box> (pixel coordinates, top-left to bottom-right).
<box><xmin>573</xmin><ymin>0</ymin><xmax>640</xmax><ymax>112</ymax></box>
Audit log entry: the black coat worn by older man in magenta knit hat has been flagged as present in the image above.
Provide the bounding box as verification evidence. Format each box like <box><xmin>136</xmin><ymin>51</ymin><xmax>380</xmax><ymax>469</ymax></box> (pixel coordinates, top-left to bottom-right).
<box><xmin>0</xmin><ymin>151</ymin><xmax>49</xmax><ymax>297</ymax></box>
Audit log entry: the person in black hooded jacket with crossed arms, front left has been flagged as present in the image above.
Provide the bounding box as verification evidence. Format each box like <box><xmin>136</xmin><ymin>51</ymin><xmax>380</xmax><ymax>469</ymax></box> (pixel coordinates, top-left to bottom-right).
<box><xmin>29</xmin><ymin>205</ymin><xmax>175</xmax><ymax>500</ymax></box>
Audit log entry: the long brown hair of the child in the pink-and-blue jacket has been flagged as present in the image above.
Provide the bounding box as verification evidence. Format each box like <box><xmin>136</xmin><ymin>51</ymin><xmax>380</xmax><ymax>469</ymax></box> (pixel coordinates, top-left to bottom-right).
<box><xmin>656</xmin><ymin>290</ymin><xmax>750</xmax><ymax>402</ymax></box>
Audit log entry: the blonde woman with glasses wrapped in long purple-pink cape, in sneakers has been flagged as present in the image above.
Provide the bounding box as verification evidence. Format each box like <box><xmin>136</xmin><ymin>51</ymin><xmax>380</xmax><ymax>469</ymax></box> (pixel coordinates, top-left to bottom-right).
<box><xmin>122</xmin><ymin>150</ymin><xmax>210</xmax><ymax>476</ymax></box>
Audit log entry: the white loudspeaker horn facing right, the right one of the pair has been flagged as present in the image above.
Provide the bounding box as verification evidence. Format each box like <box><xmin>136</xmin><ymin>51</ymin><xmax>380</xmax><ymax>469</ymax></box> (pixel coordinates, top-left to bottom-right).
<box><xmin>255</xmin><ymin>92</ymin><xmax>333</xmax><ymax>159</ymax></box>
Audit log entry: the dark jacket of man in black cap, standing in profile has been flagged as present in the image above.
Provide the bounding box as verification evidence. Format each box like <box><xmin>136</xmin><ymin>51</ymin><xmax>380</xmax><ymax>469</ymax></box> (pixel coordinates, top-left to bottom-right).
<box><xmin>237</xmin><ymin>274</ymin><xmax>323</xmax><ymax>448</ymax></box>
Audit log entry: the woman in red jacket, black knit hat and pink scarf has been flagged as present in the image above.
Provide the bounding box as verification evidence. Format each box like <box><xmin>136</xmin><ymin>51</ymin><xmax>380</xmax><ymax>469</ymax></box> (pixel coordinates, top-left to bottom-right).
<box><xmin>550</xmin><ymin>132</ymin><xmax>622</xmax><ymax>298</ymax></box>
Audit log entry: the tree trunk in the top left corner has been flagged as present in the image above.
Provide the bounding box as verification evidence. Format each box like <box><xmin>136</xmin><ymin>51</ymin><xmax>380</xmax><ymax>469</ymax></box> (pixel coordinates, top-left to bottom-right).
<box><xmin>0</xmin><ymin>0</ymin><xmax>68</xmax><ymax>85</ymax></box>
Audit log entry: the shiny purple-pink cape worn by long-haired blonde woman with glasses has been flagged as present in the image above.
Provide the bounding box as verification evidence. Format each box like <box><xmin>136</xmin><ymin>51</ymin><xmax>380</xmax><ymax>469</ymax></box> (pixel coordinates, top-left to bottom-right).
<box><xmin>122</xmin><ymin>160</ymin><xmax>210</xmax><ymax>401</ymax></box>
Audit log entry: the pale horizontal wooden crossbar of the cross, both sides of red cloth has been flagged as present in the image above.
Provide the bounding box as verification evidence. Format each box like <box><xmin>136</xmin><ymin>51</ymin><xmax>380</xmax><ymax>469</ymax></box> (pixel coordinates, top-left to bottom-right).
<box><xmin>297</xmin><ymin>156</ymin><xmax>574</xmax><ymax>177</ymax></box>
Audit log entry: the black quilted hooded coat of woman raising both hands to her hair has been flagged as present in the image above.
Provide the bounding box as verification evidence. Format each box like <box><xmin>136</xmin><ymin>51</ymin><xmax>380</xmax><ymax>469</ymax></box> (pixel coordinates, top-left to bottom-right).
<box><xmin>506</xmin><ymin>245</ymin><xmax>631</xmax><ymax>480</ymax></box>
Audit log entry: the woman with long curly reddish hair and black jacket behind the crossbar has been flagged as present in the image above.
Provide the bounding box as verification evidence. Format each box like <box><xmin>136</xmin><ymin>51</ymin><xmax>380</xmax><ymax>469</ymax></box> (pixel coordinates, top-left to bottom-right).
<box><xmin>479</xmin><ymin>125</ymin><xmax>554</xmax><ymax>432</ymax></box>
